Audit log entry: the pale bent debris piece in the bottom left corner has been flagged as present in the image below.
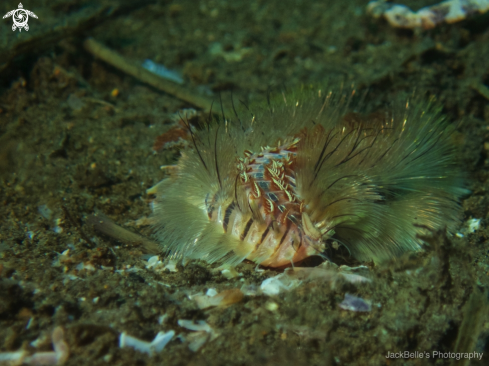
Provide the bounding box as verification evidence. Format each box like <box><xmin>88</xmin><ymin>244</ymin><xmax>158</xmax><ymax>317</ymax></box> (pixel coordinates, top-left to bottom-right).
<box><xmin>0</xmin><ymin>327</ymin><xmax>70</xmax><ymax>366</ymax></box>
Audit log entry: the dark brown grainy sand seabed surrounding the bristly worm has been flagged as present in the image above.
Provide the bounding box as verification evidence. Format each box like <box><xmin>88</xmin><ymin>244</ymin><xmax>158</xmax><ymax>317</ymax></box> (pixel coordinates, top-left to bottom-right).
<box><xmin>0</xmin><ymin>0</ymin><xmax>489</xmax><ymax>366</ymax></box>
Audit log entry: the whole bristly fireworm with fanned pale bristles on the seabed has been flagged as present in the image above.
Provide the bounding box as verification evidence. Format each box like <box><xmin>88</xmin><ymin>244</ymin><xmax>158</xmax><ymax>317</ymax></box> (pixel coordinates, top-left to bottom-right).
<box><xmin>148</xmin><ymin>91</ymin><xmax>467</xmax><ymax>267</ymax></box>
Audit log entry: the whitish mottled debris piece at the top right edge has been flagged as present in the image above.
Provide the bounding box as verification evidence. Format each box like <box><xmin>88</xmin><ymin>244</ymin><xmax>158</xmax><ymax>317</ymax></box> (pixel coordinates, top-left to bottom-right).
<box><xmin>367</xmin><ymin>0</ymin><xmax>489</xmax><ymax>29</ymax></box>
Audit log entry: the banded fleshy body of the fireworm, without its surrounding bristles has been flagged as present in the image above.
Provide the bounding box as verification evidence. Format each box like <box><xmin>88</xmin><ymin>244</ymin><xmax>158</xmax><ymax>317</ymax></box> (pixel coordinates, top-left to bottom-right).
<box><xmin>206</xmin><ymin>138</ymin><xmax>324</xmax><ymax>267</ymax></box>
